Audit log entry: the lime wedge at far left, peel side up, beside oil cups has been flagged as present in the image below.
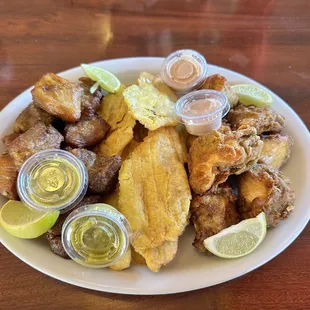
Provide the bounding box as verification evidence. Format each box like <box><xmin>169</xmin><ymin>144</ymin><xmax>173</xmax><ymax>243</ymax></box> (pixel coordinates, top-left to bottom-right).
<box><xmin>0</xmin><ymin>200</ymin><xmax>59</xmax><ymax>239</ymax></box>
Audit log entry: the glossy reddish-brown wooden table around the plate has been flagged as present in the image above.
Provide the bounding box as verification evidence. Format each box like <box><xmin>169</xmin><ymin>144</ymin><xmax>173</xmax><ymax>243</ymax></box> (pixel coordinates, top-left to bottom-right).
<box><xmin>0</xmin><ymin>0</ymin><xmax>310</xmax><ymax>310</ymax></box>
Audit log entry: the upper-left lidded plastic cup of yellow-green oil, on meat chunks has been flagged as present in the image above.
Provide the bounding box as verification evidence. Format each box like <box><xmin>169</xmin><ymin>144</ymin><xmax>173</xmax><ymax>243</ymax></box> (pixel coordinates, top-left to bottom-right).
<box><xmin>17</xmin><ymin>149</ymin><xmax>88</xmax><ymax>213</ymax></box>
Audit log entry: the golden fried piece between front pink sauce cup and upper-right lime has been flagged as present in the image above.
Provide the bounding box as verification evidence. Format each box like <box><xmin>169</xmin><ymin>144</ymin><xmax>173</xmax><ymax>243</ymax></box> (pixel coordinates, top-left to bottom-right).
<box><xmin>200</xmin><ymin>74</ymin><xmax>239</xmax><ymax>107</ymax></box>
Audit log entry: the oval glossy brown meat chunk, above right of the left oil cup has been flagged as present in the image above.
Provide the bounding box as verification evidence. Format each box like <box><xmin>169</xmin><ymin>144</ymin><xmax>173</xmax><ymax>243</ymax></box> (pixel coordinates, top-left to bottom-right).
<box><xmin>65</xmin><ymin>116</ymin><xmax>110</xmax><ymax>148</ymax></box>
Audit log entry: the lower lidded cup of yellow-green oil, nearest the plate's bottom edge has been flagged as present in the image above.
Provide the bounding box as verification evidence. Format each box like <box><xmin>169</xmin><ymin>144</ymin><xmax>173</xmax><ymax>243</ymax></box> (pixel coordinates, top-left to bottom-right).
<box><xmin>62</xmin><ymin>203</ymin><xmax>130</xmax><ymax>268</ymax></box>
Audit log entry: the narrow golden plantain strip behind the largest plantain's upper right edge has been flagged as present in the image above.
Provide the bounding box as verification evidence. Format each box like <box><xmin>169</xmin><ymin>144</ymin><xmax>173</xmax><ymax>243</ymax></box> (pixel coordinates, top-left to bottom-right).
<box><xmin>149</xmin><ymin>127</ymin><xmax>188</xmax><ymax>164</ymax></box>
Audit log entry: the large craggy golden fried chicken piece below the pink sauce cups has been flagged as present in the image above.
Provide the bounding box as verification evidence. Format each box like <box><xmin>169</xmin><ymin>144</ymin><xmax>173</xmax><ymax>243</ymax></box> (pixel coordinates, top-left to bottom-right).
<box><xmin>188</xmin><ymin>126</ymin><xmax>263</xmax><ymax>194</ymax></box>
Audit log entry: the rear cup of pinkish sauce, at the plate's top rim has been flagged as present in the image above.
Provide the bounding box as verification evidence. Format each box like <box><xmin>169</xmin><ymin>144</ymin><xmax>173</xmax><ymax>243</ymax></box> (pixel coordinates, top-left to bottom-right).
<box><xmin>161</xmin><ymin>50</ymin><xmax>208</xmax><ymax>95</ymax></box>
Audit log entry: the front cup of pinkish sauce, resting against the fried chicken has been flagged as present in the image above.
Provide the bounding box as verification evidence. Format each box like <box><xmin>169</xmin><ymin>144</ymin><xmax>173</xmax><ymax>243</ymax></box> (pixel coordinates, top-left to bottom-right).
<box><xmin>175</xmin><ymin>89</ymin><xmax>230</xmax><ymax>136</ymax></box>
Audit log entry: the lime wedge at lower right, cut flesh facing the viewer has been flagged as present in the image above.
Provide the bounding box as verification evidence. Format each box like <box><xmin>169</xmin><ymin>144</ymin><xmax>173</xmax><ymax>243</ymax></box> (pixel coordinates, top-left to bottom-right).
<box><xmin>204</xmin><ymin>212</ymin><xmax>267</xmax><ymax>258</ymax></box>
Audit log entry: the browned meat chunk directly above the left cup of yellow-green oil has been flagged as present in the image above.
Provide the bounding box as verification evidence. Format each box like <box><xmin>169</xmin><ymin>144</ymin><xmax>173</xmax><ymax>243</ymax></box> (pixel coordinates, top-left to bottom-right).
<box><xmin>8</xmin><ymin>123</ymin><xmax>63</xmax><ymax>170</ymax></box>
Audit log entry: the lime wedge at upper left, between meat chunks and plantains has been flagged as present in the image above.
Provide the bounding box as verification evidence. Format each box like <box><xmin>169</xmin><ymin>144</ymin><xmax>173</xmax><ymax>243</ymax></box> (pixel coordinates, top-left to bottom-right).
<box><xmin>81</xmin><ymin>64</ymin><xmax>121</xmax><ymax>93</ymax></box>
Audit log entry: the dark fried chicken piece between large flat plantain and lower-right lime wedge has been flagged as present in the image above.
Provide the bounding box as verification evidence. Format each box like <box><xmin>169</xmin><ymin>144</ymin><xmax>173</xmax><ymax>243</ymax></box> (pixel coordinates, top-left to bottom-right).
<box><xmin>191</xmin><ymin>184</ymin><xmax>240</xmax><ymax>252</ymax></box>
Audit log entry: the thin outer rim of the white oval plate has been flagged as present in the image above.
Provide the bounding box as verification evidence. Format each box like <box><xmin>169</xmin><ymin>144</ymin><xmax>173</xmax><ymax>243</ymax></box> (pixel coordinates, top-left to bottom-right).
<box><xmin>0</xmin><ymin>57</ymin><xmax>310</xmax><ymax>295</ymax></box>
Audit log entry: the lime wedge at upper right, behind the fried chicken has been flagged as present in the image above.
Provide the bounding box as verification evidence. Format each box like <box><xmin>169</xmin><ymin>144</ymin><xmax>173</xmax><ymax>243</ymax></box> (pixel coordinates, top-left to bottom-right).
<box><xmin>231</xmin><ymin>84</ymin><xmax>273</xmax><ymax>108</ymax></box>
